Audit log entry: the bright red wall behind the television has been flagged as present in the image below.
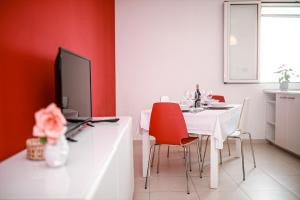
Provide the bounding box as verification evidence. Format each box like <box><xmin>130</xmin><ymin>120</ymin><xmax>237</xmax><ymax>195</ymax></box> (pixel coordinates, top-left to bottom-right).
<box><xmin>0</xmin><ymin>0</ymin><xmax>115</xmax><ymax>160</ymax></box>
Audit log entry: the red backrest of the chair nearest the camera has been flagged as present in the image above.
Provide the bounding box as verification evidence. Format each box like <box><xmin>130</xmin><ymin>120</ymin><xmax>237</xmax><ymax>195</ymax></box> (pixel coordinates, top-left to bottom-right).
<box><xmin>149</xmin><ymin>102</ymin><xmax>188</xmax><ymax>145</ymax></box>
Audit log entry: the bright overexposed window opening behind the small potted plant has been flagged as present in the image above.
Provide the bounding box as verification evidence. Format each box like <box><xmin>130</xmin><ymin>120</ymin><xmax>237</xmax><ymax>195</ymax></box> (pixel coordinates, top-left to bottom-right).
<box><xmin>260</xmin><ymin>4</ymin><xmax>300</xmax><ymax>82</ymax></box>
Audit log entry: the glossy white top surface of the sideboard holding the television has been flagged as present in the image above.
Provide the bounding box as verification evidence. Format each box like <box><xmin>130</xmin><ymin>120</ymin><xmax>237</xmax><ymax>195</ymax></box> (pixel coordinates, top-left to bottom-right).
<box><xmin>0</xmin><ymin>117</ymin><xmax>132</xmax><ymax>199</ymax></box>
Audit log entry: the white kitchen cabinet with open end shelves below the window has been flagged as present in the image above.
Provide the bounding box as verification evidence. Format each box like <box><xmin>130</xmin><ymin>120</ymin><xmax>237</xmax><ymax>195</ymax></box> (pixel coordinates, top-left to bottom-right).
<box><xmin>265</xmin><ymin>91</ymin><xmax>300</xmax><ymax>155</ymax></box>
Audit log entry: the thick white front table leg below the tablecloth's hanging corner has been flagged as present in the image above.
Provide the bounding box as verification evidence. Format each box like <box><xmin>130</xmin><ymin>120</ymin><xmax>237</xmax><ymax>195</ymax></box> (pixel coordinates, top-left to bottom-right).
<box><xmin>210</xmin><ymin>136</ymin><xmax>219</xmax><ymax>189</ymax></box>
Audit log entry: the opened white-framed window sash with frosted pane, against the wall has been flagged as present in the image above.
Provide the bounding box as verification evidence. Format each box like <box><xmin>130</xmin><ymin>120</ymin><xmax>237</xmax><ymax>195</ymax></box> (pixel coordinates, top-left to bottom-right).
<box><xmin>224</xmin><ymin>2</ymin><xmax>259</xmax><ymax>83</ymax></box>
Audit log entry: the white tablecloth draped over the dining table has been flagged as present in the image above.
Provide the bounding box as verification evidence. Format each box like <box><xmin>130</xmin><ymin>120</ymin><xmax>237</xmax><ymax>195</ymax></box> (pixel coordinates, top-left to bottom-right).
<box><xmin>140</xmin><ymin>104</ymin><xmax>241</xmax><ymax>149</ymax></box>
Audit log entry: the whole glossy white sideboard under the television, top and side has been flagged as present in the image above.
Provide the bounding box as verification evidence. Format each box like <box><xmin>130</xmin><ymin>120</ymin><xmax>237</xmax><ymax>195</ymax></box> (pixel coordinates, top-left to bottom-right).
<box><xmin>0</xmin><ymin>117</ymin><xmax>134</xmax><ymax>200</ymax></box>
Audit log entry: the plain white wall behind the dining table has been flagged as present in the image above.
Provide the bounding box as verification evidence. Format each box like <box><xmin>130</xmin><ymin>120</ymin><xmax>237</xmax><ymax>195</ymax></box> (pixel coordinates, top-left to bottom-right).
<box><xmin>115</xmin><ymin>0</ymin><xmax>300</xmax><ymax>138</ymax></box>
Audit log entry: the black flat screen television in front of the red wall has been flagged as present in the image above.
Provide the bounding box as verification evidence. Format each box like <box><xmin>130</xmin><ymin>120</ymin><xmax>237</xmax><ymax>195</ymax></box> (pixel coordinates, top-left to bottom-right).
<box><xmin>55</xmin><ymin>48</ymin><xmax>92</xmax><ymax>122</ymax></box>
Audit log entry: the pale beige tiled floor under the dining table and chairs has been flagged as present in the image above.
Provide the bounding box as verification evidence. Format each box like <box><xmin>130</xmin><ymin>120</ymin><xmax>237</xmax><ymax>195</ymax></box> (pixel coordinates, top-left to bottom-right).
<box><xmin>134</xmin><ymin>141</ymin><xmax>300</xmax><ymax>200</ymax></box>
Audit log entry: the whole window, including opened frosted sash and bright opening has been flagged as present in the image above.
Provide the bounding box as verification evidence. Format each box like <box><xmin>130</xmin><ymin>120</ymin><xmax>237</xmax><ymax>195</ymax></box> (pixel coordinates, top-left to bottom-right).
<box><xmin>224</xmin><ymin>1</ymin><xmax>300</xmax><ymax>83</ymax></box>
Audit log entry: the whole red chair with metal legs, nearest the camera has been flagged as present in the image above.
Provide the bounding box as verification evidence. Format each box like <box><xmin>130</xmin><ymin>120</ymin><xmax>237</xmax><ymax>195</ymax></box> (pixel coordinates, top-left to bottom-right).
<box><xmin>145</xmin><ymin>102</ymin><xmax>200</xmax><ymax>194</ymax></box>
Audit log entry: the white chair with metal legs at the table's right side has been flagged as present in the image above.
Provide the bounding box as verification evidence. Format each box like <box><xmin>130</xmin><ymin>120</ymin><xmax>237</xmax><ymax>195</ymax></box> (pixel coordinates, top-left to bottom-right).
<box><xmin>200</xmin><ymin>98</ymin><xmax>256</xmax><ymax>181</ymax></box>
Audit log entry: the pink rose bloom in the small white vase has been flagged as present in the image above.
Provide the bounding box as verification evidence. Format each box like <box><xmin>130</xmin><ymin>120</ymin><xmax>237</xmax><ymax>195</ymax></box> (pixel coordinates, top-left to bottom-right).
<box><xmin>33</xmin><ymin>103</ymin><xmax>66</xmax><ymax>144</ymax></box>
